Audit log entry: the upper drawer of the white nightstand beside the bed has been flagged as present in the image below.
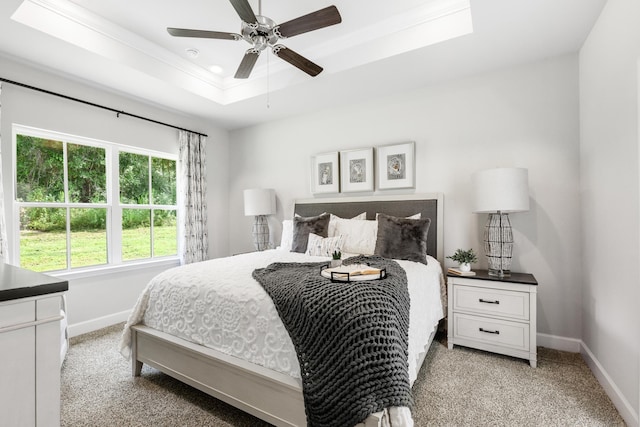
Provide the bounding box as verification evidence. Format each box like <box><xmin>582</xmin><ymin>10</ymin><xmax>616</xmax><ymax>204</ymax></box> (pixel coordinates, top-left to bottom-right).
<box><xmin>453</xmin><ymin>285</ymin><xmax>529</xmax><ymax>320</ymax></box>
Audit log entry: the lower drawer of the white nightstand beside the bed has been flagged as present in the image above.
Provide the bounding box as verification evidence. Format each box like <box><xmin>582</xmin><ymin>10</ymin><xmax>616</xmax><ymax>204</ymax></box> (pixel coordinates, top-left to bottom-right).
<box><xmin>453</xmin><ymin>313</ymin><xmax>529</xmax><ymax>351</ymax></box>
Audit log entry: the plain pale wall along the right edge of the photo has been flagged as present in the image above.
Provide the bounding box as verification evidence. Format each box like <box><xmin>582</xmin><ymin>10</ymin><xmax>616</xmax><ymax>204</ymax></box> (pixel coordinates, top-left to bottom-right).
<box><xmin>580</xmin><ymin>0</ymin><xmax>640</xmax><ymax>426</ymax></box>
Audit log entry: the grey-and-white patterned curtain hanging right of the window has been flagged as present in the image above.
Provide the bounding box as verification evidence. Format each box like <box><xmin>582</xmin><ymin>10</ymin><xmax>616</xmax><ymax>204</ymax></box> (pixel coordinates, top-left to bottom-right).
<box><xmin>179</xmin><ymin>130</ymin><xmax>209</xmax><ymax>264</ymax></box>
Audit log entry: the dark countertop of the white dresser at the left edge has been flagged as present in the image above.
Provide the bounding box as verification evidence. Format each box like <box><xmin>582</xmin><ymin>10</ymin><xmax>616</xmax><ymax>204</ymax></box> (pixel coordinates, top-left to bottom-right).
<box><xmin>0</xmin><ymin>263</ymin><xmax>69</xmax><ymax>302</ymax></box>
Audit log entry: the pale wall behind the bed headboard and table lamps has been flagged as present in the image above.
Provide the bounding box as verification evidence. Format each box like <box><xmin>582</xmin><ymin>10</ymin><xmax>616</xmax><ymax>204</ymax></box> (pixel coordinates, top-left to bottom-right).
<box><xmin>229</xmin><ymin>55</ymin><xmax>582</xmax><ymax>344</ymax></box>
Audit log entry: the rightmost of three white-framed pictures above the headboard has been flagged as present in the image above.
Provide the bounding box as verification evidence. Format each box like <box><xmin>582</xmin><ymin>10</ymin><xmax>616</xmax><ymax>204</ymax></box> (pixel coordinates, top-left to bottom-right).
<box><xmin>376</xmin><ymin>142</ymin><xmax>416</xmax><ymax>190</ymax></box>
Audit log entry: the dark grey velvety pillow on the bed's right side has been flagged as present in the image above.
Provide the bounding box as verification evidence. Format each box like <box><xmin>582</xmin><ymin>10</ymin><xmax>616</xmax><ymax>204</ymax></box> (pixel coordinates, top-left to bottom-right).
<box><xmin>375</xmin><ymin>214</ymin><xmax>431</xmax><ymax>264</ymax></box>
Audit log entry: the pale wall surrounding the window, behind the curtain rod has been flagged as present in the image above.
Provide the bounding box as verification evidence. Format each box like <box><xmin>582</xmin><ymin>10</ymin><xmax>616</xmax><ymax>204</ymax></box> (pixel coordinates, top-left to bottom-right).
<box><xmin>0</xmin><ymin>57</ymin><xmax>228</xmax><ymax>334</ymax></box>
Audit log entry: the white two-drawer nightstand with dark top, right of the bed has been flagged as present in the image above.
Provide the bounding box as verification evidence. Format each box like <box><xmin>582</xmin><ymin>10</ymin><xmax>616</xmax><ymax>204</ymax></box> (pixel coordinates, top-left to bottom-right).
<box><xmin>447</xmin><ymin>270</ymin><xmax>538</xmax><ymax>368</ymax></box>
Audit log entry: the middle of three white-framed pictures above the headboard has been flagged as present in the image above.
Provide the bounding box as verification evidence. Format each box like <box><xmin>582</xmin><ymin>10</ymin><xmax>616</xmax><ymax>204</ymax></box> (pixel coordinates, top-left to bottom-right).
<box><xmin>340</xmin><ymin>147</ymin><xmax>375</xmax><ymax>193</ymax></box>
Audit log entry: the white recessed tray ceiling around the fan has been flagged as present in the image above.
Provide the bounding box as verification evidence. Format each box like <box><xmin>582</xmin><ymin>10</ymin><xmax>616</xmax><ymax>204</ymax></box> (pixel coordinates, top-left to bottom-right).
<box><xmin>0</xmin><ymin>0</ymin><xmax>605</xmax><ymax>129</ymax></box>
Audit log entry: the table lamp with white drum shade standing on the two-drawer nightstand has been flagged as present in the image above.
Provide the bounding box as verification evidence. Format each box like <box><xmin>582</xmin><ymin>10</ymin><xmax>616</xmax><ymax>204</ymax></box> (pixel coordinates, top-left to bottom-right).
<box><xmin>472</xmin><ymin>168</ymin><xmax>529</xmax><ymax>278</ymax></box>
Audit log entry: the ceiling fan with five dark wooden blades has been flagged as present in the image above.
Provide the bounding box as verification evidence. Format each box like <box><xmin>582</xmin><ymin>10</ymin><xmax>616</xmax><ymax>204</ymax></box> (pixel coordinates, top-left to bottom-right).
<box><xmin>167</xmin><ymin>0</ymin><xmax>342</xmax><ymax>79</ymax></box>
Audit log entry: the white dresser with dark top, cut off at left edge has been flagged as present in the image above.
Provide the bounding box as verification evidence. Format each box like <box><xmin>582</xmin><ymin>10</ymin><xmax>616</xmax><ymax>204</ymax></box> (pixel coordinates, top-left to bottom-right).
<box><xmin>0</xmin><ymin>263</ymin><xmax>68</xmax><ymax>427</ymax></box>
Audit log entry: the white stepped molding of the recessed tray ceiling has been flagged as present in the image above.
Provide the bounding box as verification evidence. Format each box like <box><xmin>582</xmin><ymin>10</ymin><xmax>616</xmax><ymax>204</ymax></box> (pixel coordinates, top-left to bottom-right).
<box><xmin>12</xmin><ymin>0</ymin><xmax>473</xmax><ymax>105</ymax></box>
